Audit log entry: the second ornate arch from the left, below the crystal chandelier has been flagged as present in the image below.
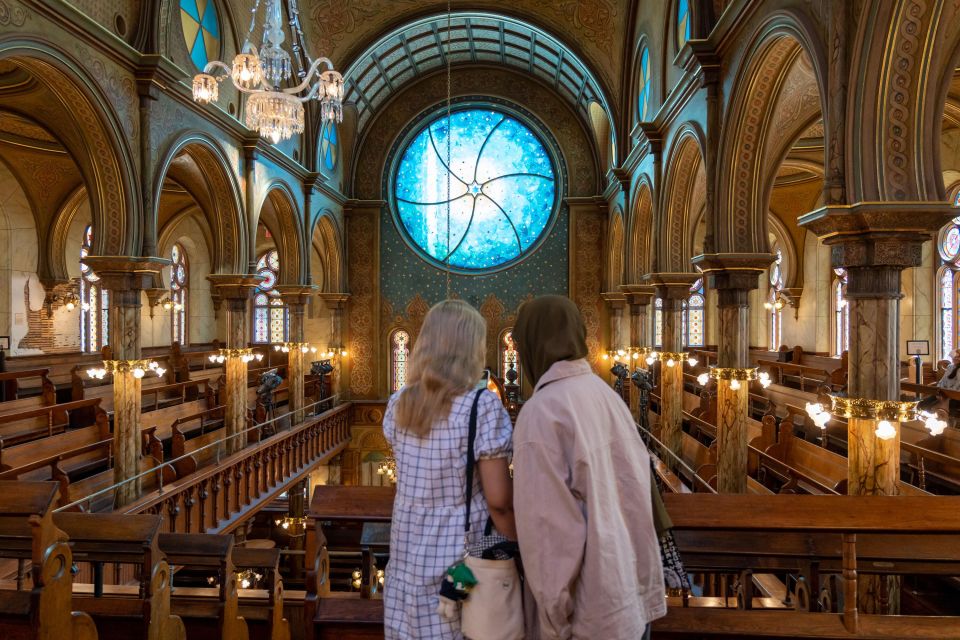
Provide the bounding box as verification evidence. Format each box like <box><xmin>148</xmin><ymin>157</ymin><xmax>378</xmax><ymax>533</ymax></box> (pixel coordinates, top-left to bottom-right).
<box><xmin>149</xmin><ymin>131</ymin><xmax>249</xmax><ymax>273</ymax></box>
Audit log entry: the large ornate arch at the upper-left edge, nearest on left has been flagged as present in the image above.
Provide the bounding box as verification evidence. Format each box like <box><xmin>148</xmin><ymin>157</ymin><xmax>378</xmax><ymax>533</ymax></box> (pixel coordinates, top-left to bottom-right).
<box><xmin>0</xmin><ymin>34</ymin><xmax>142</xmax><ymax>255</ymax></box>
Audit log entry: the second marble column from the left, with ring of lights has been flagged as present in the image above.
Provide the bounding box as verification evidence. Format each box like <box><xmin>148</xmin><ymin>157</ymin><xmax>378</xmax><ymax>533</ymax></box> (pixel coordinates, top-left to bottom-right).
<box><xmin>207</xmin><ymin>274</ymin><xmax>261</xmax><ymax>455</ymax></box>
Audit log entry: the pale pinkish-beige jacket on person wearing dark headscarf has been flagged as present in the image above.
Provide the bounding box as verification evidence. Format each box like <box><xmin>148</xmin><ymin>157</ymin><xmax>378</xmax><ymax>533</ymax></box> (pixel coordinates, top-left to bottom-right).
<box><xmin>513</xmin><ymin>360</ymin><xmax>667</xmax><ymax>640</ymax></box>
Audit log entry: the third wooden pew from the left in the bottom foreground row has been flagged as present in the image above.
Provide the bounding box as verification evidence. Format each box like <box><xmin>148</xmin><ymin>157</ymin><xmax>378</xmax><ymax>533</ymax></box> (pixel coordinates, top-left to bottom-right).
<box><xmin>160</xmin><ymin>533</ymin><xmax>249</xmax><ymax>640</ymax></box>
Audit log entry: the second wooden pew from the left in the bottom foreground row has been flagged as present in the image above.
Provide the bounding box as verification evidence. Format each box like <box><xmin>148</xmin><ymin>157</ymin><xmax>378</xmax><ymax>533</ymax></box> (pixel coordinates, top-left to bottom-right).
<box><xmin>53</xmin><ymin>513</ymin><xmax>186</xmax><ymax>640</ymax></box>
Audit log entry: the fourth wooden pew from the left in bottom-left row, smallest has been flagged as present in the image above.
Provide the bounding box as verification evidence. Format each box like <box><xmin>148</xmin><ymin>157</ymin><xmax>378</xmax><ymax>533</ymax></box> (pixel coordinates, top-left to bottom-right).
<box><xmin>233</xmin><ymin>547</ymin><xmax>290</xmax><ymax>640</ymax></box>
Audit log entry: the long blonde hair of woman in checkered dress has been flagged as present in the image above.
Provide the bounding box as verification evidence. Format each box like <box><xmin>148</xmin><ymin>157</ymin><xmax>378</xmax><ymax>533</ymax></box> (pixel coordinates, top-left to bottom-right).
<box><xmin>396</xmin><ymin>300</ymin><xmax>487</xmax><ymax>437</ymax></box>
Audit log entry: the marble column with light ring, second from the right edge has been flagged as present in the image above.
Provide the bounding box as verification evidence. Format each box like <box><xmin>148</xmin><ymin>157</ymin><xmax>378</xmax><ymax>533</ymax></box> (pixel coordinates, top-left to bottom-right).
<box><xmin>695</xmin><ymin>254</ymin><xmax>773</xmax><ymax>493</ymax></box>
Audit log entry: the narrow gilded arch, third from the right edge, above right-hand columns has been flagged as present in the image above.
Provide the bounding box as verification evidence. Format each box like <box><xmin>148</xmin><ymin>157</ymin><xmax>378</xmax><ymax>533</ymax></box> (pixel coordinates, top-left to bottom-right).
<box><xmin>654</xmin><ymin>124</ymin><xmax>706</xmax><ymax>273</ymax></box>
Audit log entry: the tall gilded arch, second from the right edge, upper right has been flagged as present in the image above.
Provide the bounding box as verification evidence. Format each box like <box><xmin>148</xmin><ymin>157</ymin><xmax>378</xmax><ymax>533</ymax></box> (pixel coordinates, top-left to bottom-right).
<box><xmin>720</xmin><ymin>12</ymin><xmax>825</xmax><ymax>253</ymax></box>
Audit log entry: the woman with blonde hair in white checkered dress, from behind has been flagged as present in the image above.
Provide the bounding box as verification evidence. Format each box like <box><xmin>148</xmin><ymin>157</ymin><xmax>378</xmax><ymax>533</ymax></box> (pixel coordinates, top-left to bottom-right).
<box><xmin>383</xmin><ymin>300</ymin><xmax>516</xmax><ymax>640</ymax></box>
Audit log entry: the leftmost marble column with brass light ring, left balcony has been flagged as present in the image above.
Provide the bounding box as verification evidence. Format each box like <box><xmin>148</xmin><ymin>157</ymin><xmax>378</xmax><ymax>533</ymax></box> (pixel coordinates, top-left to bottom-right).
<box><xmin>83</xmin><ymin>256</ymin><xmax>170</xmax><ymax>508</ymax></box>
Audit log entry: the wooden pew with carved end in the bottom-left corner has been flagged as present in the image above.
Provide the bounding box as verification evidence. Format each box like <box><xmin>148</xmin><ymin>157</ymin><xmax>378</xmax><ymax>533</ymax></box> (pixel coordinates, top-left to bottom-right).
<box><xmin>0</xmin><ymin>482</ymin><xmax>97</xmax><ymax>640</ymax></box>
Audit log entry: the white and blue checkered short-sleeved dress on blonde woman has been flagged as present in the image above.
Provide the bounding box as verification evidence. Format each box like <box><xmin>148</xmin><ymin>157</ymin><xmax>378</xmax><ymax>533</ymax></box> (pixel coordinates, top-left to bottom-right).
<box><xmin>383</xmin><ymin>390</ymin><xmax>513</xmax><ymax>640</ymax></box>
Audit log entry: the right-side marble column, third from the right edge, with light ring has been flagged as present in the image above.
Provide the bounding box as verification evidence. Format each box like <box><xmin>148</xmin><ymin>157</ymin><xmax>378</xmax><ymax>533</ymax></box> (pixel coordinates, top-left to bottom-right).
<box><xmin>647</xmin><ymin>273</ymin><xmax>700</xmax><ymax>467</ymax></box>
